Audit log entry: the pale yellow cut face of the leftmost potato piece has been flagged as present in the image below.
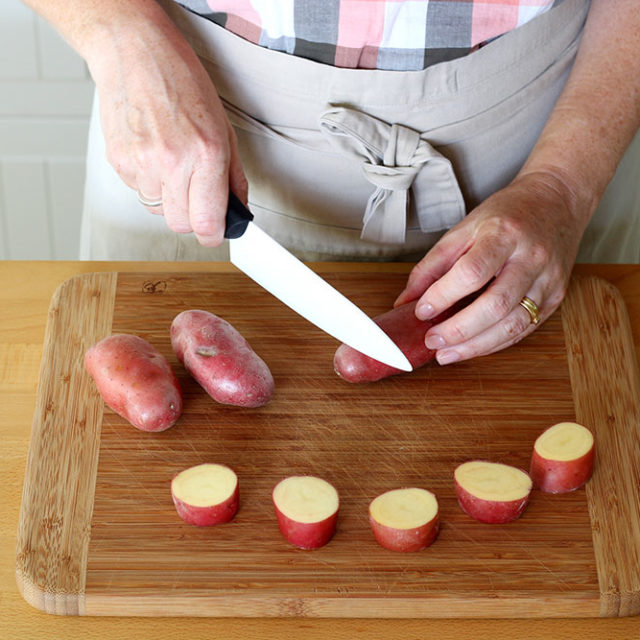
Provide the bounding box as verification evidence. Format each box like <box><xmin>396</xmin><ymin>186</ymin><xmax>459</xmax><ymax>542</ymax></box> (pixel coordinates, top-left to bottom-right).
<box><xmin>171</xmin><ymin>463</ymin><xmax>238</xmax><ymax>507</ymax></box>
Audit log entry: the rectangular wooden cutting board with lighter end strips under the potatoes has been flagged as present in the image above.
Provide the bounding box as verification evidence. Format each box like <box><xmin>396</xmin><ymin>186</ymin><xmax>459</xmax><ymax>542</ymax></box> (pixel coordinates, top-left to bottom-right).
<box><xmin>16</xmin><ymin>269</ymin><xmax>640</xmax><ymax>618</ymax></box>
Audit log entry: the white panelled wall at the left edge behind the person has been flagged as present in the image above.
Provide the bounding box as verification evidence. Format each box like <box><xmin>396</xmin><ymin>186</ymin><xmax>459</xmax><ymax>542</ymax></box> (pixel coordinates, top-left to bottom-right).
<box><xmin>0</xmin><ymin>0</ymin><xmax>93</xmax><ymax>259</ymax></box>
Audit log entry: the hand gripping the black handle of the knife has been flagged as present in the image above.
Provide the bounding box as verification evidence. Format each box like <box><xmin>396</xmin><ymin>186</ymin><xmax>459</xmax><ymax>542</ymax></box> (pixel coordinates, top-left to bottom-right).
<box><xmin>87</xmin><ymin>9</ymin><xmax>247</xmax><ymax>246</ymax></box>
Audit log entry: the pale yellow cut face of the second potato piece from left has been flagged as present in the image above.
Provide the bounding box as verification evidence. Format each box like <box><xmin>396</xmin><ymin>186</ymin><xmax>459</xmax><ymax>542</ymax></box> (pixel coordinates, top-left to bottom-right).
<box><xmin>273</xmin><ymin>476</ymin><xmax>339</xmax><ymax>524</ymax></box>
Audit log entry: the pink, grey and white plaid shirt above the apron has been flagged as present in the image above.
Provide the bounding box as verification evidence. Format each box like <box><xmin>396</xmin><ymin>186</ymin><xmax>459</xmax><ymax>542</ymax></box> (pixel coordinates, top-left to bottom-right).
<box><xmin>176</xmin><ymin>0</ymin><xmax>562</xmax><ymax>71</ymax></box>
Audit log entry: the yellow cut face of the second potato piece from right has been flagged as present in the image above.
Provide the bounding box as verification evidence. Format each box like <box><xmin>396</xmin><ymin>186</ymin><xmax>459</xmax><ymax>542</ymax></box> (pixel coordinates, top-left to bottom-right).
<box><xmin>455</xmin><ymin>460</ymin><xmax>532</xmax><ymax>502</ymax></box>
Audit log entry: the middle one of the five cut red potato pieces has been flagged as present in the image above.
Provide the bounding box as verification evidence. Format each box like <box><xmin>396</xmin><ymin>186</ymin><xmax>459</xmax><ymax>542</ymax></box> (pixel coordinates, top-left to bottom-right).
<box><xmin>369</xmin><ymin>488</ymin><xmax>440</xmax><ymax>552</ymax></box>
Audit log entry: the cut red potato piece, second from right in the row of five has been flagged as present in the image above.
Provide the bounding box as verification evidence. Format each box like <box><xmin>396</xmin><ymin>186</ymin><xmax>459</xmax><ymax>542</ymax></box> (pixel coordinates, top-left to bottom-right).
<box><xmin>454</xmin><ymin>460</ymin><xmax>532</xmax><ymax>524</ymax></box>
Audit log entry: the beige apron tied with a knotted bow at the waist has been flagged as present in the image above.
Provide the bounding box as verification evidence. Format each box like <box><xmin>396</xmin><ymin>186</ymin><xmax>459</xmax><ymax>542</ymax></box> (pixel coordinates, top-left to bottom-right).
<box><xmin>81</xmin><ymin>0</ymin><xmax>636</xmax><ymax>260</ymax></box>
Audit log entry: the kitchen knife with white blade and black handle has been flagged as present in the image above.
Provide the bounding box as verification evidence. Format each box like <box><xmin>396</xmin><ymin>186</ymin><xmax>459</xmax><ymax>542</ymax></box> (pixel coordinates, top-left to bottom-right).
<box><xmin>224</xmin><ymin>191</ymin><xmax>413</xmax><ymax>371</ymax></box>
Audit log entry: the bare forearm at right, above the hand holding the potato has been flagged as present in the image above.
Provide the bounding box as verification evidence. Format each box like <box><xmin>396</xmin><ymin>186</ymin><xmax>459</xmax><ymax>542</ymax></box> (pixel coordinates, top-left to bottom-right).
<box><xmin>521</xmin><ymin>0</ymin><xmax>640</xmax><ymax>225</ymax></box>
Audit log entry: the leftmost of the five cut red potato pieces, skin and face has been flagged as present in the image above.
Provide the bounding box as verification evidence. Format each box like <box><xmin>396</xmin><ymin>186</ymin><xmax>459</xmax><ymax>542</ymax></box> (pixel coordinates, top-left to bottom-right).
<box><xmin>171</xmin><ymin>463</ymin><xmax>240</xmax><ymax>527</ymax></box>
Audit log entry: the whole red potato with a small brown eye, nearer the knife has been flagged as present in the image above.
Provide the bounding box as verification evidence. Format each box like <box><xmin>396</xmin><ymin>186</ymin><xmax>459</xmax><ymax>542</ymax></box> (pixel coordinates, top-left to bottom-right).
<box><xmin>171</xmin><ymin>309</ymin><xmax>275</xmax><ymax>407</ymax></box>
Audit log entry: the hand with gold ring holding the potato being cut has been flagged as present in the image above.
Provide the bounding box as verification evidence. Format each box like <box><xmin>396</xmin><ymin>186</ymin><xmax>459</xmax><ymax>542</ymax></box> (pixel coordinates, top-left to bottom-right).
<box><xmin>395</xmin><ymin>172</ymin><xmax>587</xmax><ymax>364</ymax></box>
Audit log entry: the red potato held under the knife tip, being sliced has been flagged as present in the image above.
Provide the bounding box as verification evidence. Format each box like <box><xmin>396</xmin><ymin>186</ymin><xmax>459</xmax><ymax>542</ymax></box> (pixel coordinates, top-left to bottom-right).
<box><xmin>333</xmin><ymin>301</ymin><xmax>453</xmax><ymax>382</ymax></box>
